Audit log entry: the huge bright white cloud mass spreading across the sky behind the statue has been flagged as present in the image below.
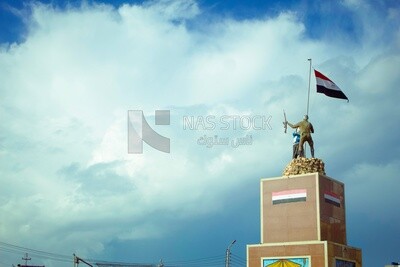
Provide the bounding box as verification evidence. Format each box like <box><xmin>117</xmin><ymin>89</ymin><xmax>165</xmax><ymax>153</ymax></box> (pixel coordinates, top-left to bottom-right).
<box><xmin>0</xmin><ymin>1</ymin><xmax>400</xmax><ymax>266</ymax></box>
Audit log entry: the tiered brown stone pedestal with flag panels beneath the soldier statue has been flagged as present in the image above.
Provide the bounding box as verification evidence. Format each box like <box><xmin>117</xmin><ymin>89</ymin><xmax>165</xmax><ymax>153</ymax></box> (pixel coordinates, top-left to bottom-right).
<box><xmin>247</xmin><ymin>173</ymin><xmax>362</xmax><ymax>267</ymax></box>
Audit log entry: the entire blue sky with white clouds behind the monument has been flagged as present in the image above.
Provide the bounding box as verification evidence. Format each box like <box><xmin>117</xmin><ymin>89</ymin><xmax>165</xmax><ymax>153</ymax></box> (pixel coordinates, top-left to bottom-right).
<box><xmin>0</xmin><ymin>0</ymin><xmax>400</xmax><ymax>267</ymax></box>
